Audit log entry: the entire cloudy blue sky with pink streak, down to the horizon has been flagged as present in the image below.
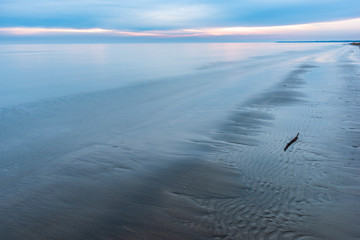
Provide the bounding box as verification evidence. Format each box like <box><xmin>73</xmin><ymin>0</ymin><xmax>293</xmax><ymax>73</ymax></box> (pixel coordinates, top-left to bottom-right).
<box><xmin>0</xmin><ymin>0</ymin><xmax>360</xmax><ymax>42</ymax></box>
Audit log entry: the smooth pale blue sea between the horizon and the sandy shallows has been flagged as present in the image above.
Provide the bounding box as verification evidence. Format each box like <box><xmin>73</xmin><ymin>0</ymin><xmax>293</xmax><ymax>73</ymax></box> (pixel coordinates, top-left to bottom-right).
<box><xmin>0</xmin><ymin>43</ymin><xmax>334</xmax><ymax>107</ymax></box>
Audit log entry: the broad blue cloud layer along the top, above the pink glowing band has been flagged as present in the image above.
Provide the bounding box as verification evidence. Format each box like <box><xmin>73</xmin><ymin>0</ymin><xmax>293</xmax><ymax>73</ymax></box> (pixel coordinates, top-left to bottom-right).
<box><xmin>0</xmin><ymin>0</ymin><xmax>360</xmax><ymax>31</ymax></box>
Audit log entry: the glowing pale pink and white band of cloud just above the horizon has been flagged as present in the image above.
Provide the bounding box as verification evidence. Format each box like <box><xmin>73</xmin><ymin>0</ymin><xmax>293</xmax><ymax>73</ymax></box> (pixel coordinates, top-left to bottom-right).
<box><xmin>0</xmin><ymin>18</ymin><xmax>360</xmax><ymax>40</ymax></box>
